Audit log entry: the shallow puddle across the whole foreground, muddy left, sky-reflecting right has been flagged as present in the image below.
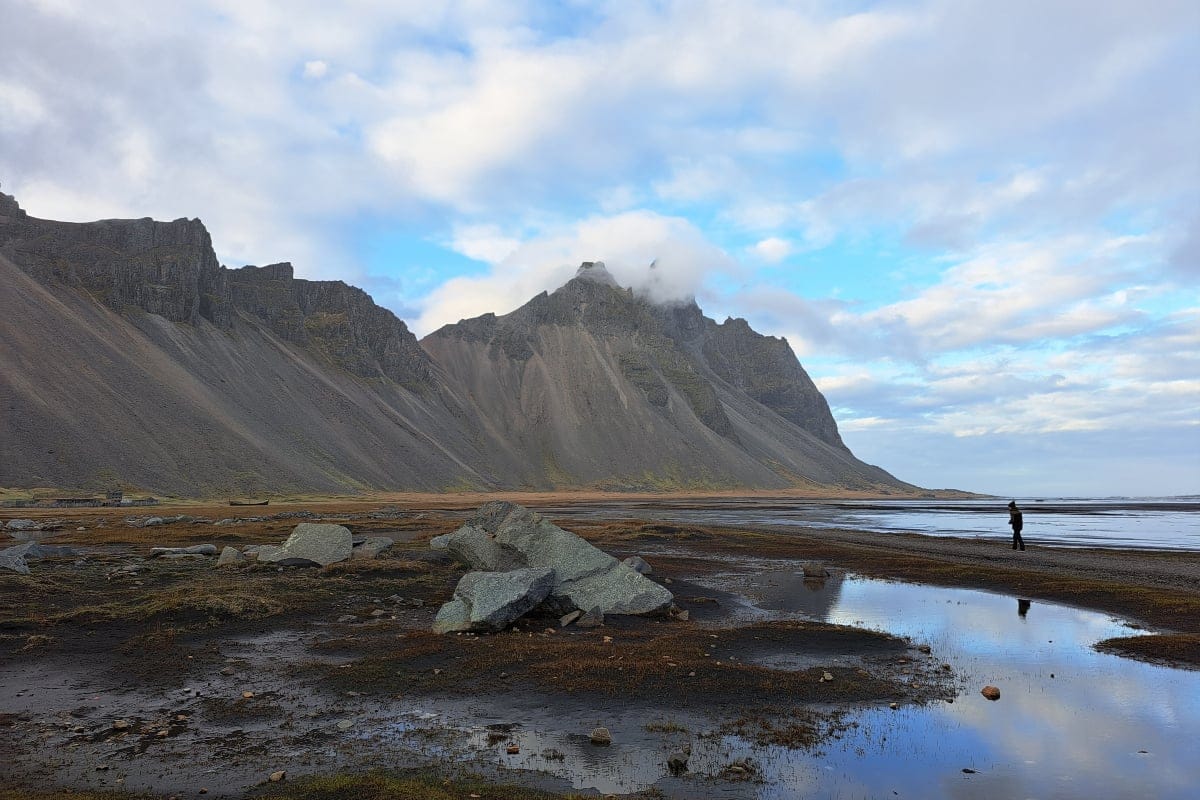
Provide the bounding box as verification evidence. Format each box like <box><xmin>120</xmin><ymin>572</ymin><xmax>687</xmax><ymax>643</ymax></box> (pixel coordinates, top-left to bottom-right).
<box><xmin>0</xmin><ymin>569</ymin><xmax>1200</xmax><ymax>800</ymax></box>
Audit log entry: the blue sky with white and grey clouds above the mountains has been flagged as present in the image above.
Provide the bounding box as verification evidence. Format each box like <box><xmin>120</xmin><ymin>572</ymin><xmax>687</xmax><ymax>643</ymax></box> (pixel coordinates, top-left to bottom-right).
<box><xmin>0</xmin><ymin>0</ymin><xmax>1200</xmax><ymax>497</ymax></box>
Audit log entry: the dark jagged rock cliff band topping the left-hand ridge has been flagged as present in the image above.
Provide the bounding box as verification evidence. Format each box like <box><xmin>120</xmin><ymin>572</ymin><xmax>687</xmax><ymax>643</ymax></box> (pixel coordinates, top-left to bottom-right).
<box><xmin>0</xmin><ymin>184</ymin><xmax>433</xmax><ymax>390</ymax></box>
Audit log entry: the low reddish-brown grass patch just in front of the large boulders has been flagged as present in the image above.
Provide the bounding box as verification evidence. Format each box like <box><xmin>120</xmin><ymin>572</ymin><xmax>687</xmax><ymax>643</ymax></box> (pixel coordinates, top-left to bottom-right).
<box><xmin>323</xmin><ymin>622</ymin><xmax>938</xmax><ymax>704</ymax></box>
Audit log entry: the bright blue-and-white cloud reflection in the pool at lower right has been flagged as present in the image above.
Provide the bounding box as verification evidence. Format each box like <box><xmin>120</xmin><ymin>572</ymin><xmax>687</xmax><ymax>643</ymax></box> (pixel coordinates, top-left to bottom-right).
<box><xmin>816</xmin><ymin>581</ymin><xmax>1200</xmax><ymax>796</ymax></box>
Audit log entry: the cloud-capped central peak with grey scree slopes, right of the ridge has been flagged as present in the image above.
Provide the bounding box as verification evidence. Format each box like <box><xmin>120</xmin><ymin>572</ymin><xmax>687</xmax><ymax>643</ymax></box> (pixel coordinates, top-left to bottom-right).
<box><xmin>421</xmin><ymin>263</ymin><xmax>905</xmax><ymax>489</ymax></box>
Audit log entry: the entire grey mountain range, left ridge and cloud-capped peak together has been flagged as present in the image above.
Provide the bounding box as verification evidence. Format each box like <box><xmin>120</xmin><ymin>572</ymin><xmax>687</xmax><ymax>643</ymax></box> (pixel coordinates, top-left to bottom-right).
<box><xmin>0</xmin><ymin>193</ymin><xmax>917</xmax><ymax>497</ymax></box>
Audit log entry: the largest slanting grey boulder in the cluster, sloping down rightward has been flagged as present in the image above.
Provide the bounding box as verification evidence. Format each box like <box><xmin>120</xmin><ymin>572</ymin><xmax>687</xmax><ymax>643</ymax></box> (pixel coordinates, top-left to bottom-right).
<box><xmin>460</xmin><ymin>503</ymin><xmax>673</xmax><ymax>614</ymax></box>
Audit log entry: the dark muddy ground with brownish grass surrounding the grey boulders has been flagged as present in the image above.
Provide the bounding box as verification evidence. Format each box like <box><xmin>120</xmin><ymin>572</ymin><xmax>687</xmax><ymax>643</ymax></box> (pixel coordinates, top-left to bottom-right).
<box><xmin>0</xmin><ymin>503</ymin><xmax>1200</xmax><ymax>798</ymax></box>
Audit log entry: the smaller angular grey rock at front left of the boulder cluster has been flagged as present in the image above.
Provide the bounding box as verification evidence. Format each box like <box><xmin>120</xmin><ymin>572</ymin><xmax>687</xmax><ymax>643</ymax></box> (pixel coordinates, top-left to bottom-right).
<box><xmin>433</xmin><ymin>569</ymin><xmax>554</xmax><ymax>633</ymax></box>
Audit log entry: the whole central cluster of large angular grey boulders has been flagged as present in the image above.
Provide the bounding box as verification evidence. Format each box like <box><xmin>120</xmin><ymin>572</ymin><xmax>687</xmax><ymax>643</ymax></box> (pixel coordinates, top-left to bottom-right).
<box><xmin>430</xmin><ymin>503</ymin><xmax>673</xmax><ymax>633</ymax></box>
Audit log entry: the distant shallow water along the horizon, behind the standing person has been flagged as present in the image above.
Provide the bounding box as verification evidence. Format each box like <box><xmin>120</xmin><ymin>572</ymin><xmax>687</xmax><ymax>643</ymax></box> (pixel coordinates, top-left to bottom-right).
<box><xmin>540</xmin><ymin>498</ymin><xmax>1200</xmax><ymax>551</ymax></box>
